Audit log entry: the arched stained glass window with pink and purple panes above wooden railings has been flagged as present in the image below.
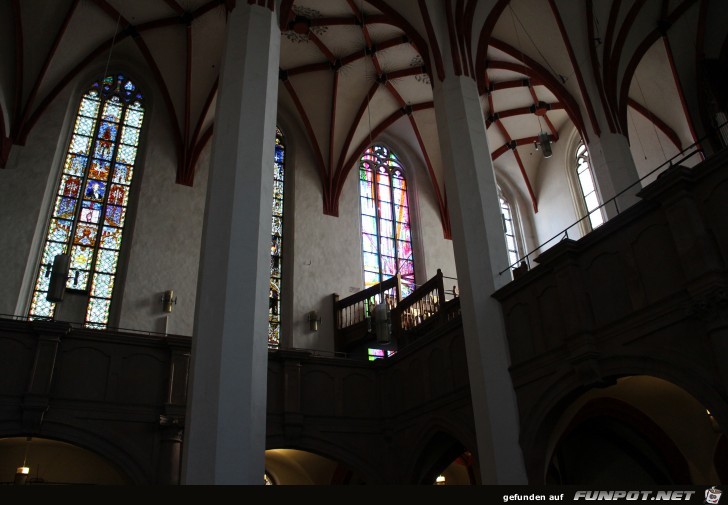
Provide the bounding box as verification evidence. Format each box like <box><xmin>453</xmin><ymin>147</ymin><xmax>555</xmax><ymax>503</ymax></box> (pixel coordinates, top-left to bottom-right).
<box><xmin>359</xmin><ymin>145</ymin><xmax>415</xmax><ymax>297</ymax></box>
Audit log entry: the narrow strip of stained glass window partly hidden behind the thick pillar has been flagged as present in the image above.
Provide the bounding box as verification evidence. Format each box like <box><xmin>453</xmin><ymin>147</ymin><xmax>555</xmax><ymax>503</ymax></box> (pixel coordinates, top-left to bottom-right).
<box><xmin>268</xmin><ymin>128</ymin><xmax>286</xmax><ymax>348</ymax></box>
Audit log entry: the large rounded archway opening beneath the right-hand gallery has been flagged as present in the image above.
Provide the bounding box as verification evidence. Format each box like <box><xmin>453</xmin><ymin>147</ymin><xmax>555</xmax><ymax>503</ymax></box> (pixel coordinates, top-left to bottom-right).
<box><xmin>546</xmin><ymin>375</ymin><xmax>717</xmax><ymax>486</ymax></box>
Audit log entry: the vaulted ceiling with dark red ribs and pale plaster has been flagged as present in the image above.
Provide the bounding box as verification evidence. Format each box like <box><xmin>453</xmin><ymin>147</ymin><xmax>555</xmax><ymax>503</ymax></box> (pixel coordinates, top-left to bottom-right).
<box><xmin>0</xmin><ymin>0</ymin><xmax>717</xmax><ymax>235</ymax></box>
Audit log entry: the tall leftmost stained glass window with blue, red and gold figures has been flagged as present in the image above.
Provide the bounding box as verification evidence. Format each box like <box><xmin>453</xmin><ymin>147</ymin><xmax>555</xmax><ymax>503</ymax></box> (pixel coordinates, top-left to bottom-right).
<box><xmin>29</xmin><ymin>74</ymin><xmax>144</xmax><ymax>328</ymax></box>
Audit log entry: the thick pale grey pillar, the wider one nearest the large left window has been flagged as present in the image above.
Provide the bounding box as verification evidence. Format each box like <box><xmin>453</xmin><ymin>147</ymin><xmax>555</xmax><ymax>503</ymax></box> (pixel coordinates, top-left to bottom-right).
<box><xmin>182</xmin><ymin>1</ymin><xmax>280</xmax><ymax>485</ymax></box>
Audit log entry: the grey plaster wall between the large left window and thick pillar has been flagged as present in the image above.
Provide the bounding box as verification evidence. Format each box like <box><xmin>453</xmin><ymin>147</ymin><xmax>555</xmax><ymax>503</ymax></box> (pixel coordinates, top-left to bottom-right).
<box><xmin>119</xmin><ymin>113</ymin><xmax>211</xmax><ymax>335</ymax></box>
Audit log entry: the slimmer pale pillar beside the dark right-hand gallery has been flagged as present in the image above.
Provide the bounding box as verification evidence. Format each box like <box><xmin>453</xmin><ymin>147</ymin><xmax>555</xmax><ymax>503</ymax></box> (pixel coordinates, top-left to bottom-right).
<box><xmin>434</xmin><ymin>75</ymin><xmax>528</xmax><ymax>484</ymax></box>
